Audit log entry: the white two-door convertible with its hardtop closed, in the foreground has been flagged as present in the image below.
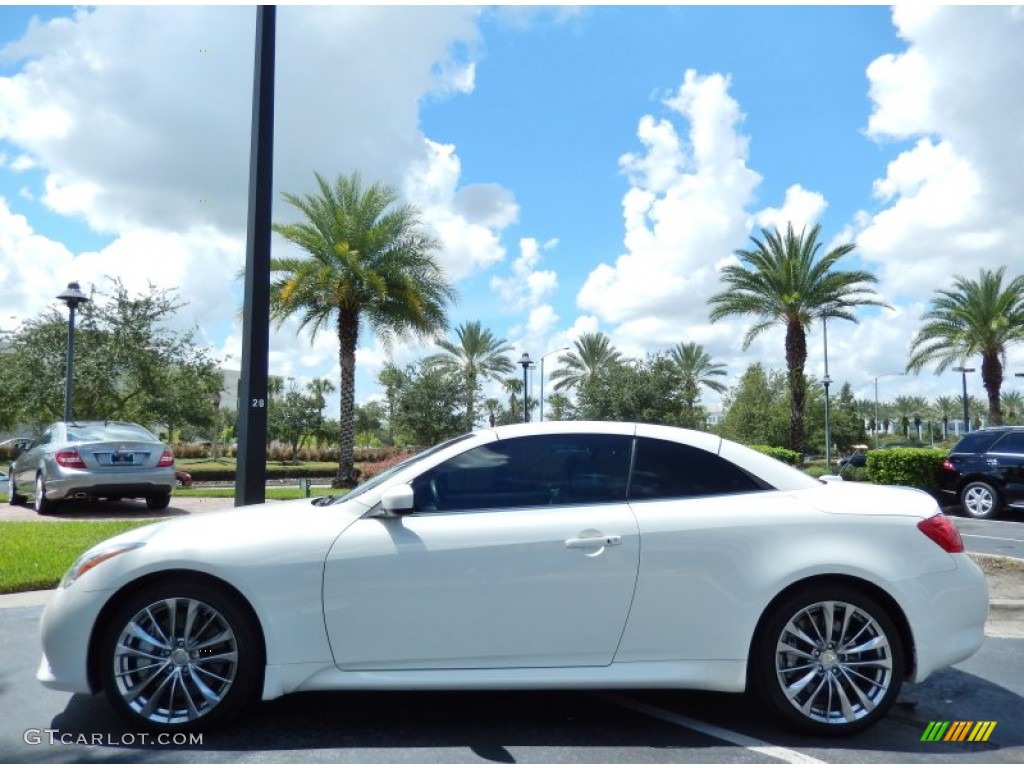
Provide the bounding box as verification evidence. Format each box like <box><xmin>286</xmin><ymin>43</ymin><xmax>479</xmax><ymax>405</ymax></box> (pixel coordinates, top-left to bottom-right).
<box><xmin>38</xmin><ymin>422</ymin><xmax>988</xmax><ymax>734</ymax></box>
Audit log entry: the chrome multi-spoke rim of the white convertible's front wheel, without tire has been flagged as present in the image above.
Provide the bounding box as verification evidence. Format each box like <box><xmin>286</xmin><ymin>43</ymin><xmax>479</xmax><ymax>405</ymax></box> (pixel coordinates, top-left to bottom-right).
<box><xmin>113</xmin><ymin>597</ymin><xmax>239</xmax><ymax>725</ymax></box>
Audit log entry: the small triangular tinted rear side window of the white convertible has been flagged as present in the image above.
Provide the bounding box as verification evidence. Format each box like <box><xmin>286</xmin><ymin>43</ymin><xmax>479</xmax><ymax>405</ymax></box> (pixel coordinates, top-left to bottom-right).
<box><xmin>629</xmin><ymin>437</ymin><xmax>767</xmax><ymax>501</ymax></box>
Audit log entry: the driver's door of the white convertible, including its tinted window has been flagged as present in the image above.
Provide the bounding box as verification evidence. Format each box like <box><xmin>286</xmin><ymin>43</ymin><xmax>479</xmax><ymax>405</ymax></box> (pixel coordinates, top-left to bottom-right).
<box><xmin>324</xmin><ymin>434</ymin><xmax>640</xmax><ymax>670</ymax></box>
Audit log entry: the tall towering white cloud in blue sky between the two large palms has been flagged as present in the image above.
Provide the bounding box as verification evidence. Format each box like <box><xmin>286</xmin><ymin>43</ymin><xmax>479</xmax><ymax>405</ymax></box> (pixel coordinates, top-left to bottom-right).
<box><xmin>577</xmin><ymin>71</ymin><xmax>761</xmax><ymax>349</ymax></box>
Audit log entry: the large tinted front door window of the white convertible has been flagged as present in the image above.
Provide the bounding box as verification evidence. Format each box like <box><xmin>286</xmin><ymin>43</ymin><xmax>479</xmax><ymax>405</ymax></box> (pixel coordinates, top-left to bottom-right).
<box><xmin>413</xmin><ymin>434</ymin><xmax>633</xmax><ymax>512</ymax></box>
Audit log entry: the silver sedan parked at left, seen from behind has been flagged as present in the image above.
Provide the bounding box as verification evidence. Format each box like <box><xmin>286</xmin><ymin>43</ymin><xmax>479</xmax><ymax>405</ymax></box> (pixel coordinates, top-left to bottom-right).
<box><xmin>7</xmin><ymin>421</ymin><xmax>176</xmax><ymax>515</ymax></box>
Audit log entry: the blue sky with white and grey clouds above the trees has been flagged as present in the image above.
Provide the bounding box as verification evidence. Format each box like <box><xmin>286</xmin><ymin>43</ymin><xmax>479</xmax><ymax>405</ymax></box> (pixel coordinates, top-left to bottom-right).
<box><xmin>0</xmin><ymin>3</ymin><xmax>1024</xmax><ymax>415</ymax></box>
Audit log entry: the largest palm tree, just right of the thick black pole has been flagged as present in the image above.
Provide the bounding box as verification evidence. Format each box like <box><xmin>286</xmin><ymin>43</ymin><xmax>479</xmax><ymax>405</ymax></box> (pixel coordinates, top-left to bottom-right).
<box><xmin>270</xmin><ymin>173</ymin><xmax>455</xmax><ymax>487</ymax></box>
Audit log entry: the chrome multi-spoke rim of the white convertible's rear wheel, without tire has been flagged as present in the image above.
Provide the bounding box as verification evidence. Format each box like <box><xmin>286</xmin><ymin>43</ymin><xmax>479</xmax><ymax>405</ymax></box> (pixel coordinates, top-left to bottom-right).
<box><xmin>775</xmin><ymin>600</ymin><xmax>894</xmax><ymax>724</ymax></box>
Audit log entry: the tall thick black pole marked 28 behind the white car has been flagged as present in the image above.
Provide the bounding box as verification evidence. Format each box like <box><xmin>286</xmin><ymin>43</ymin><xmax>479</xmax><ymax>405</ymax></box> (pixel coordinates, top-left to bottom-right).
<box><xmin>234</xmin><ymin>5</ymin><xmax>276</xmax><ymax>507</ymax></box>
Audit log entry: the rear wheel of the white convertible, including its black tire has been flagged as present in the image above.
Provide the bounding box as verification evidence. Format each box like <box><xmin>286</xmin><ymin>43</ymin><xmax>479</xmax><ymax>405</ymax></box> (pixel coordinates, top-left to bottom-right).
<box><xmin>751</xmin><ymin>585</ymin><xmax>904</xmax><ymax>735</ymax></box>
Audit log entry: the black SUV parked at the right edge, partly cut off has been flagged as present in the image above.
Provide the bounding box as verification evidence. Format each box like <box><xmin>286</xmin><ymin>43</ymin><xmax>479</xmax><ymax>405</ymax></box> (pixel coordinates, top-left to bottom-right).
<box><xmin>939</xmin><ymin>427</ymin><xmax>1024</xmax><ymax>518</ymax></box>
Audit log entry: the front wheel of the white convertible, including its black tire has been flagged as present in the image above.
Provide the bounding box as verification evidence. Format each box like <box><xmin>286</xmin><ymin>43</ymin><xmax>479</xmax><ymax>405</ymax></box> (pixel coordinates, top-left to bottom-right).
<box><xmin>99</xmin><ymin>579</ymin><xmax>263</xmax><ymax>731</ymax></box>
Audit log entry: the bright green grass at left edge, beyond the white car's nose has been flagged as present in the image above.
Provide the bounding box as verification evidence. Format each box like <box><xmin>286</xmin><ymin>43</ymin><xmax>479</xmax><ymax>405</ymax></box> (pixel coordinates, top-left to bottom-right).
<box><xmin>0</xmin><ymin>520</ymin><xmax>152</xmax><ymax>594</ymax></box>
